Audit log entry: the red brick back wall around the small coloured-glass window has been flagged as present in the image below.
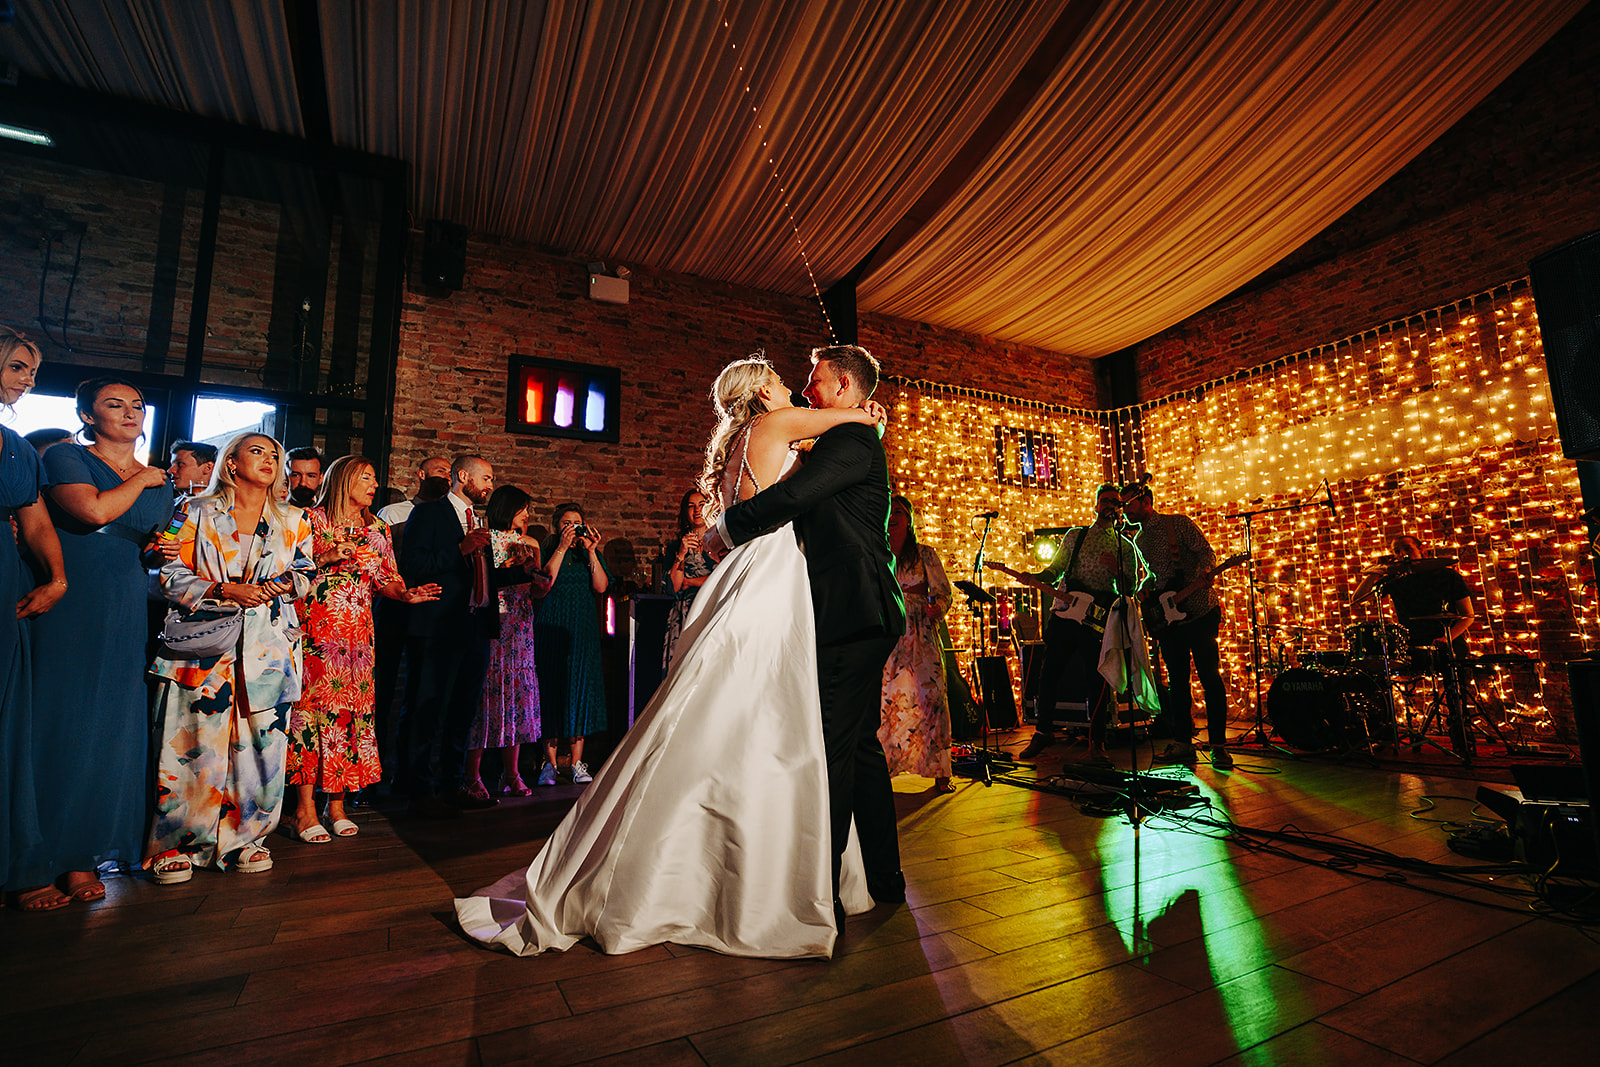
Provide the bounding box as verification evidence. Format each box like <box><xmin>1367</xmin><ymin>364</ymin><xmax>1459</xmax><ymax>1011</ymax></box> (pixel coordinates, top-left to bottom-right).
<box><xmin>390</xmin><ymin>237</ymin><xmax>1093</xmax><ymax>585</ymax></box>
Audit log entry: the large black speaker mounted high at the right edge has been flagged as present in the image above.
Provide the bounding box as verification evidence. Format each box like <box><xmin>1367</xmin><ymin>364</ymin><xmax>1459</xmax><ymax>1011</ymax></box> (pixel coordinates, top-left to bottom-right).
<box><xmin>1528</xmin><ymin>232</ymin><xmax>1600</xmax><ymax>461</ymax></box>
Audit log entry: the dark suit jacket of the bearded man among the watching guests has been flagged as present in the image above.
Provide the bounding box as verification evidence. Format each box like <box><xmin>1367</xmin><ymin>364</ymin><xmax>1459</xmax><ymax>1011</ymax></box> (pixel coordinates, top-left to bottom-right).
<box><xmin>400</xmin><ymin>496</ymin><xmax>528</xmax><ymax>638</ymax></box>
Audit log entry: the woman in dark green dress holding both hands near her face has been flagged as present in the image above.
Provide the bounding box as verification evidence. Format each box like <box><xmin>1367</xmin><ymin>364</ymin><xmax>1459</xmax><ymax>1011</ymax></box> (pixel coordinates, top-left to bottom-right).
<box><xmin>534</xmin><ymin>502</ymin><xmax>611</xmax><ymax>785</ymax></box>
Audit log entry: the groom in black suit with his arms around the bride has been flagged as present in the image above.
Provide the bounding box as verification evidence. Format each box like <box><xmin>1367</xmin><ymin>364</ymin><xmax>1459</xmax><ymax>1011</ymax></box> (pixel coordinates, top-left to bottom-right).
<box><xmin>704</xmin><ymin>344</ymin><xmax>906</xmax><ymax>929</ymax></box>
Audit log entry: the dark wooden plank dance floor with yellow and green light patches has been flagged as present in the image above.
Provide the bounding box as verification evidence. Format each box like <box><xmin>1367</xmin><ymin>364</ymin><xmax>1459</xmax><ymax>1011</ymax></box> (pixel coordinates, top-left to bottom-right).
<box><xmin>0</xmin><ymin>742</ymin><xmax>1600</xmax><ymax>1067</ymax></box>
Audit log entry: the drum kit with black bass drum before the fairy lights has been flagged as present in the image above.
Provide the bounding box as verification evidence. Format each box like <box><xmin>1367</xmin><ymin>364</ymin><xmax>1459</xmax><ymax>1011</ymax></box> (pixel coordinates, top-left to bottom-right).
<box><xmin>1267</xmin><ymin>557</ymin><xmax>1474</xmax><ymax>763</ymax></box>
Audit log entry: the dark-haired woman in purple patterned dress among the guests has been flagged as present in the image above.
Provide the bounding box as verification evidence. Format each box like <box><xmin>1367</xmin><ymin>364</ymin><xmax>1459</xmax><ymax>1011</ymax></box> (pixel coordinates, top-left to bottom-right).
<box><xmin>467</xmin><ymin>485</ymin><xmax>550</xmax><ymax>797</ymax></box>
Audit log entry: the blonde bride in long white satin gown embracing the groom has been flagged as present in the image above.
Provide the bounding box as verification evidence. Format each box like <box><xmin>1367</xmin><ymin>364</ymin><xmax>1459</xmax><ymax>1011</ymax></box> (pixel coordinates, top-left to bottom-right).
<box><xmin>456</xmin><ymin>358</ymin><xmax>883</xmax><ymax>958</ymax></box>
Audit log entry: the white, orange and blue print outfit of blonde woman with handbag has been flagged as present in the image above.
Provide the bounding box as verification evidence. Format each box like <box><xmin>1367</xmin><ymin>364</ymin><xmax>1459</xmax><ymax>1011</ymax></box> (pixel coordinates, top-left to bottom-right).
<box><xmin>146</xmin><ymin>498</ymin><xmax>317</xmax><ymax>867</ymax></box>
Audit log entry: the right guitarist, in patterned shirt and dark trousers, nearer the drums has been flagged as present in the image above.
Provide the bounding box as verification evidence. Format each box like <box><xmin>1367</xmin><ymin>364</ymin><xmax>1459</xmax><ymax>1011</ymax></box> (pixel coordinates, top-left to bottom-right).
<box><xmin>1122</xmin><ymin>482</ymin><xmax>1234</xmax><ymax>771</ymax></box>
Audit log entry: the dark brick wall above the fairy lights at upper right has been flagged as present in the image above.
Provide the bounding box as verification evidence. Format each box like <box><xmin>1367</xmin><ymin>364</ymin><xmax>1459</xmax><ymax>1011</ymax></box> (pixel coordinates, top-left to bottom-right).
<box><xmin>1138</xmin><ymin>5</ymin><xmax>1600</xmax><ymax>400</ymax></box>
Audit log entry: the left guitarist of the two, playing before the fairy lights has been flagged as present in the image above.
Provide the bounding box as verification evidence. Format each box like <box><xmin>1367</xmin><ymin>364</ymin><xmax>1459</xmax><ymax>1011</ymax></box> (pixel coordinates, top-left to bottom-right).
<box><xmin>1021</xmin><ymin>485</ymin><xmax>1144</xmax><ymax>766</ymax></box>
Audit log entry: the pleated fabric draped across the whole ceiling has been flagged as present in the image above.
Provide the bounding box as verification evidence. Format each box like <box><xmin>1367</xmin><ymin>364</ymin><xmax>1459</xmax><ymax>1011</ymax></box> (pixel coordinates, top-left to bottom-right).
<box><xmin>0</xmin><ymin>0</ymin><xmax>1584</xmax><ymax>357</ymax></box>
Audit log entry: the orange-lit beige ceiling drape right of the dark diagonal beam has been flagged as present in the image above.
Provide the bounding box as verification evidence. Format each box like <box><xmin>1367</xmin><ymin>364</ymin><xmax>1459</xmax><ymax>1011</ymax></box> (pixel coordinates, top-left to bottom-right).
<box><xmin>858</xmin><ymin>0</ymin><xmax>1582</xmax><ymax>355</ymax></box>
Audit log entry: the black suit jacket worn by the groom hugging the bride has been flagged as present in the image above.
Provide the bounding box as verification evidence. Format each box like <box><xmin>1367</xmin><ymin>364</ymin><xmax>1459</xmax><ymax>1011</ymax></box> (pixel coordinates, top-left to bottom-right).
<box><xmin>723</xmin><ymin>422</ymin><xmax>906</xmax><ymax>645</ymax></box>
